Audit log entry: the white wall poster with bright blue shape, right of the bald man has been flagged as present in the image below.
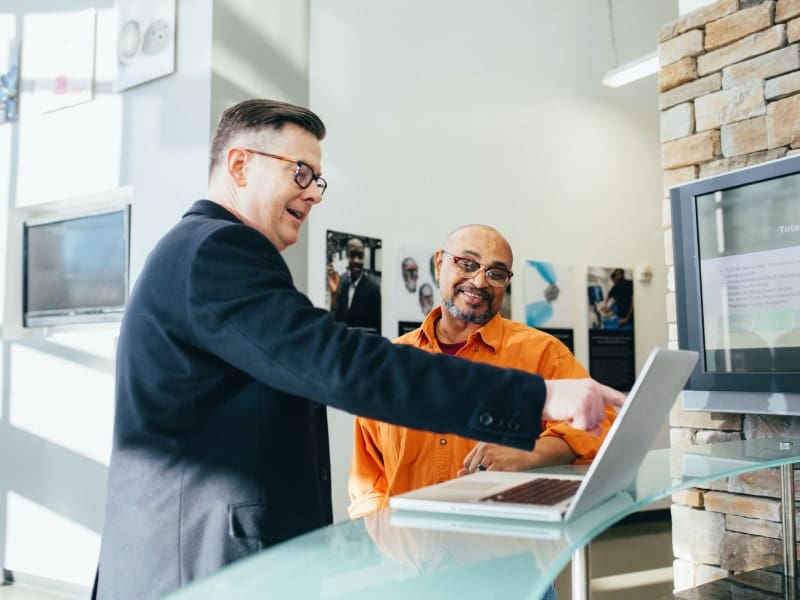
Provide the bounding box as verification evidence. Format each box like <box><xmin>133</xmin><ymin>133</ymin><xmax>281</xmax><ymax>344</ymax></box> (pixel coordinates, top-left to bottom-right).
<box><xmin>523</xmin><ymin>260</ymin><xmax>575</xmax><ymax>352</ymax></box>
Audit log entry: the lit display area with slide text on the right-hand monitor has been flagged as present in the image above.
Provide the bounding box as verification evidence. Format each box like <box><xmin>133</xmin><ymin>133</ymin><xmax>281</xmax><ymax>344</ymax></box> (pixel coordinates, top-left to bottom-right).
<box><xmin>696</xmin><ymin>174</ymin><xmax>800</xmax><ymax>373</ymax></box>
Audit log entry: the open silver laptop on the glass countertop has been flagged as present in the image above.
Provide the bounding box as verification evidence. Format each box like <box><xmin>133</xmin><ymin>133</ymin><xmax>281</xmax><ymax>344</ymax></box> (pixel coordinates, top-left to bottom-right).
<box><xmin>389</xmin><ymin>348</ymin><xmax>697</xmax><ymax>521</ymax></box>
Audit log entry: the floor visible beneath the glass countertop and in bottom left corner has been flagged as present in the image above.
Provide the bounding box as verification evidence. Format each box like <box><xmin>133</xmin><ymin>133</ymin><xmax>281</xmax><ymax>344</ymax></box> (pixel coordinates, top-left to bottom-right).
<box><xmin>0</xmin><ymin>511</ymin><xmax>672</xmax><ymax>600</ymax></box>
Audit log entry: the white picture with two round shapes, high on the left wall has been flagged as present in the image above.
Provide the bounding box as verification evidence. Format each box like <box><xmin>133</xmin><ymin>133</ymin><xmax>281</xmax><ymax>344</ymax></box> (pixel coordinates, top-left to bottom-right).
<box><xmin>113</xmin><ymin>0</ymin><xmax>175</xmax><ymax>92</ymax></box>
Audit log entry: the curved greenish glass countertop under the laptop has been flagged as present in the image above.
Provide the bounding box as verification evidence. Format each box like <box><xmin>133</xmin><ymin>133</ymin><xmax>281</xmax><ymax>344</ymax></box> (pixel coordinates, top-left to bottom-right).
<box><xmin>170</xmin><ymin>439</ymin><xmax>800</xmax><ymax>600</ymax></box>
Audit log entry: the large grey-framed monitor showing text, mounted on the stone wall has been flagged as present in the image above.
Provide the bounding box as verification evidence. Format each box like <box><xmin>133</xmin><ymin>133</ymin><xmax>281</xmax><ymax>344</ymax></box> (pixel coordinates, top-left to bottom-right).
<box><xmin>670</xmin><ymin>156</ymin><xmax>800</xmax><ymax>414</ymax></box>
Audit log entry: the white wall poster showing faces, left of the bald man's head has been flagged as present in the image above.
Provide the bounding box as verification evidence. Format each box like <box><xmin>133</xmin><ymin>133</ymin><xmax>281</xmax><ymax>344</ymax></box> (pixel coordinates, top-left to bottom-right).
<box><xmin>395</xmin><ymin>244</ymin><xmax>440</xmax><ymax>335</ymax></box>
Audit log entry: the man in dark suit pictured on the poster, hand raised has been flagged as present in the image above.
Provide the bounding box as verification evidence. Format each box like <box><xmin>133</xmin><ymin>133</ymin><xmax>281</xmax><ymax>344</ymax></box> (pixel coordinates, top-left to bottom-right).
<box><xmin>328</xmin><ymin>238</ymin><xmax>381</xmax><ymax>334</ymax></box>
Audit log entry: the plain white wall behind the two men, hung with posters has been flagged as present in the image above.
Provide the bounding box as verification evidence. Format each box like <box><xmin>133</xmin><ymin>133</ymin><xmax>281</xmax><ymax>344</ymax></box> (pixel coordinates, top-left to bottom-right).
<box><xmin>309</xmin><ymin>0</ymin><xmax>677</xmax><ymax>518</ymax></box>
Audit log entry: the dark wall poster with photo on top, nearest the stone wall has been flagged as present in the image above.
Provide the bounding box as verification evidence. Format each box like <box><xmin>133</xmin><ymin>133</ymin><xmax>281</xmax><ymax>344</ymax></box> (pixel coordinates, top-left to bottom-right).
<box><xmin>586</xmin><ymin>267</ymin><xmax>636</xmax><ymax>391</ymax></box>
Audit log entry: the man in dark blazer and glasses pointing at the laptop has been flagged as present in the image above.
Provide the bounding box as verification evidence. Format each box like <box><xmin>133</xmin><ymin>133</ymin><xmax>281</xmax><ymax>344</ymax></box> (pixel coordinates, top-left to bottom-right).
<box><xmin>96</xmin><ymin>100</ymin><xmax>624</xmax><ymax>600</ymax></box>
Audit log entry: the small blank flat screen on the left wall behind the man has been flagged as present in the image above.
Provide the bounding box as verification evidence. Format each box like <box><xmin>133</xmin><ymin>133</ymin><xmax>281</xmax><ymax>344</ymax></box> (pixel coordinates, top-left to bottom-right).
<box><xmin>22</xmin><ymin>206</ymin><xmax>130</xmax><ymax>327</ymax></box>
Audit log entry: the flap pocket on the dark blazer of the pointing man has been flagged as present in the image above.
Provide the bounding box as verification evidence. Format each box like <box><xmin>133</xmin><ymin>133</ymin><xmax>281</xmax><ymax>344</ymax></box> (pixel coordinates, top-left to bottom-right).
<box><xmin>228</xmin><ymin>503</ymin><xmax>314</xmax><ymax>544</ymax></box>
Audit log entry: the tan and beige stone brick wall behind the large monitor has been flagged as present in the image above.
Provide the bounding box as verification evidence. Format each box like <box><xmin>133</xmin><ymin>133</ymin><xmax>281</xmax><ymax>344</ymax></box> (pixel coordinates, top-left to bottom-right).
<box><xmin>658</xmin><ymin>0</ymin><xmax>800</xmax><ymax>590</ymax></box>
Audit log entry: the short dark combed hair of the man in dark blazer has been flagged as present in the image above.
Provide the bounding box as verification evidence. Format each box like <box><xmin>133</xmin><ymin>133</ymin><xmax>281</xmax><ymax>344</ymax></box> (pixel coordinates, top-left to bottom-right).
<box><xmin>208</xmin><ymin>99</ymin><xmax>325</xmax><ymax>174</ymax></box>
